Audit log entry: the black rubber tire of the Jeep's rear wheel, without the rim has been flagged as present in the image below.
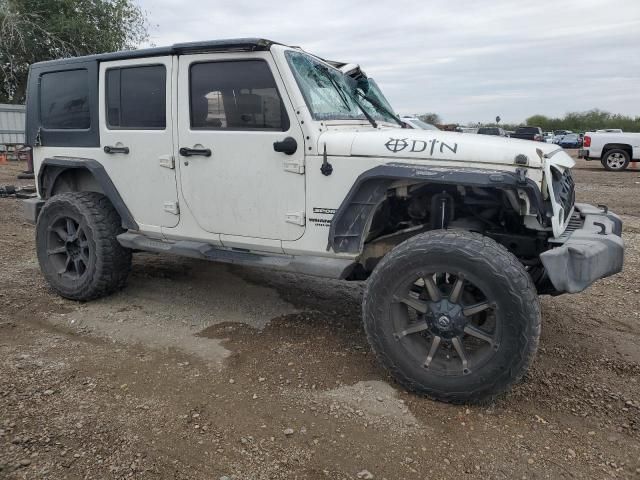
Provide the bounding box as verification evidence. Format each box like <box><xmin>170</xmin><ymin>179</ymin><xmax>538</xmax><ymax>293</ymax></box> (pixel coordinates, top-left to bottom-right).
<box><xmin>36</xmin><ymin>192</ymin><xmax>131</xmax><ymax>301</ymax></box>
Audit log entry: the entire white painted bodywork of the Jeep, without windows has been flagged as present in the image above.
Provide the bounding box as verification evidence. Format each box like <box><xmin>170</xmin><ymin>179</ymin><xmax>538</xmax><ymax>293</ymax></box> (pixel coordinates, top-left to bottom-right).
<box><xmin>34</xmin><ymin>45</ymin><xmax>574</xmax><ymax>257</ymax></box>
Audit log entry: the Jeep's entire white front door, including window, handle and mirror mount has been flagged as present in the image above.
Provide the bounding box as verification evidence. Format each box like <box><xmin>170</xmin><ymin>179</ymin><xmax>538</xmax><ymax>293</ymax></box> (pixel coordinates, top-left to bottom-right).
<box><xmin>176</xmin><ymin>52</ymin><xmax>305</xmax><ymax>243</ymax></box>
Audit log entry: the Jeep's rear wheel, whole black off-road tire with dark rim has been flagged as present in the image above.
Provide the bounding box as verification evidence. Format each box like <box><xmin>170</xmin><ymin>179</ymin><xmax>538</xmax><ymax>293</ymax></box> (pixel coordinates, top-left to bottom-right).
<box><xmin>36</xmin><ymin>192</ymin><xmax>131</xmax><ymax>301</ymax></box>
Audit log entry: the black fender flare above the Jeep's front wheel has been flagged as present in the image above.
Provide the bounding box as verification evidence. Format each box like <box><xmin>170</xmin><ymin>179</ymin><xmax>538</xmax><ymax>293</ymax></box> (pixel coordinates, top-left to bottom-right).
<box><xmin>327</xmin><ymin>163</ymin><xmax>548</xmax><ymax>254</ymax></box>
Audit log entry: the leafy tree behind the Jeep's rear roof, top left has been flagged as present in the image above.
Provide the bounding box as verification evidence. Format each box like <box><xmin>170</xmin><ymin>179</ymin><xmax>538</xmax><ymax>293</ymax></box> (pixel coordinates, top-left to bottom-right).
<box><xmin>0</xmin><ymin>0</ymin><xmax>148</xmax><ymax>103</ymax></box>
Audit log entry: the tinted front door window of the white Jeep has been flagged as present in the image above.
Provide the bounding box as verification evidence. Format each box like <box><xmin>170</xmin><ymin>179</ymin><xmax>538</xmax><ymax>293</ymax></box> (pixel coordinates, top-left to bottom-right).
<box><xmin>189</xmin><ymin>60</ymin><xmax>289</xmax><ymax>131</ymax></box>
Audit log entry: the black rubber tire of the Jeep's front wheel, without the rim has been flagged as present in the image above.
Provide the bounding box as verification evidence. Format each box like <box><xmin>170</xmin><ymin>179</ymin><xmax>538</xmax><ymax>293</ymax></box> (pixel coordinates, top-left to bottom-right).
<box><xmin>363</xmin><ymin>230</ymin><xmax>540</xmax><ymax>403</ymax></box>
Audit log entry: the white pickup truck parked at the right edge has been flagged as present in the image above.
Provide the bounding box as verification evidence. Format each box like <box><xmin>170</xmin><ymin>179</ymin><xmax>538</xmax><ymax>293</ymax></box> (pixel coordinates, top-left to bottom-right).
<box><xmin>578</xmin><ymin>131</ymin><xmax>640</xmax><ymax>172</ymax></box>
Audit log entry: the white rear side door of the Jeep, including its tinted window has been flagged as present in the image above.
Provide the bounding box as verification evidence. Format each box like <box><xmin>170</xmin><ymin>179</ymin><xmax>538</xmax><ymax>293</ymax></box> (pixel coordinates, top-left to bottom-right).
<box><xmin>97</xmin><ymin>56</ymin><xmax>179</xmax><ymax>233</ymax></box>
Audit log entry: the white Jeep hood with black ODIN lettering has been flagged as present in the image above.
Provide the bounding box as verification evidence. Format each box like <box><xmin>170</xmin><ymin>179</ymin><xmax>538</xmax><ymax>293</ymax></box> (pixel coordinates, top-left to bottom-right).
<box><xmin>318</xmin><ymin>128</ymin><xmax>574</xmax><ymax>168</ymax></box>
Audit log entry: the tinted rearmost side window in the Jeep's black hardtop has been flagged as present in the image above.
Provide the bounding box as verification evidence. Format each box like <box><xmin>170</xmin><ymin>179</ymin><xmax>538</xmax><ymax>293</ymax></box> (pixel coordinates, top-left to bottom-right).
<box><xmin>40</xmin><ymin>70</ymin><xmax>91</xmax><ymax>130</ymax></box>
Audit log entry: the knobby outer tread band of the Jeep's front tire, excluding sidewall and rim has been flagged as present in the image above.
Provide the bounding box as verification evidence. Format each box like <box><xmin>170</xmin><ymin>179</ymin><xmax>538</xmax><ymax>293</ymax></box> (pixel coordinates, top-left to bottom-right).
<box><xmin>363</xmin><ymin>230</ymin><xmax>541</xmax><ymax>404</ymax></box>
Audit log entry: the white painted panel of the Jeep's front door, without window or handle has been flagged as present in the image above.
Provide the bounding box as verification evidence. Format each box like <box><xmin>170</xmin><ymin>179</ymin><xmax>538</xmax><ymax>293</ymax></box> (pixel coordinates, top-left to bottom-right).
<box><xmin>175</xmin><ymin>52</ymin><xmax>305</xmax><ymax>250</ymax></box>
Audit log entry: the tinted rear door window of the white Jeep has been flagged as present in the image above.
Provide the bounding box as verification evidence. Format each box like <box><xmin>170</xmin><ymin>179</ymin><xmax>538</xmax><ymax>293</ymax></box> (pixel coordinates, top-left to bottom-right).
<box><xmin>106</xmin><ymin>65</ymin><xmax>167</xmax><ymax>129</ymax></box>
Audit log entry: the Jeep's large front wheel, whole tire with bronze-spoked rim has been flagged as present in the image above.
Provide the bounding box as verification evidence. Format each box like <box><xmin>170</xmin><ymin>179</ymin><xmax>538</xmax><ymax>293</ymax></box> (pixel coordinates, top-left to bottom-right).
<box><xmin>363</xmin><ymin>230</ymin><xmax>540</xmax><ymax>403</ymax></box>
